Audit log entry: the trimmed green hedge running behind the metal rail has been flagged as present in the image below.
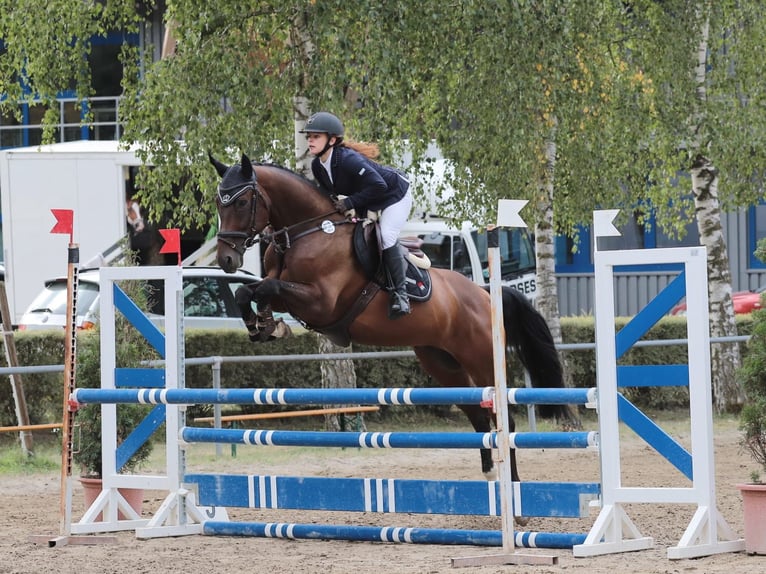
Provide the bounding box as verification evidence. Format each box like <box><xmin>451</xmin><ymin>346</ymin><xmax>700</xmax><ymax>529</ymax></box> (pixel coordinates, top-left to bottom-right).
<box><xmin>0</xmin><ymin>316</ymin><xmax>752</xmax><ymax>426</ymax></box>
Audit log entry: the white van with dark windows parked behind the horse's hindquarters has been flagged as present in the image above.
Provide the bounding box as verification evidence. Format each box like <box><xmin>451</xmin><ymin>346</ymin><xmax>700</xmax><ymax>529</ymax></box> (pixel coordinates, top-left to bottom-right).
<box><xmin>401</xmin><ymin>219</ymin><xmax>537</xmax><ymax>300</ymax></box>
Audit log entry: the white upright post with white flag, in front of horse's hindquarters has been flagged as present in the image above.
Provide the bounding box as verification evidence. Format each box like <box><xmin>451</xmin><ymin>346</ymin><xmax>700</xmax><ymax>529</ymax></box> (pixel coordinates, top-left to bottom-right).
<box><xmin>452</xmin><ymin>199</ymin><xmax>558</xmax><ymax>567</ymax></box>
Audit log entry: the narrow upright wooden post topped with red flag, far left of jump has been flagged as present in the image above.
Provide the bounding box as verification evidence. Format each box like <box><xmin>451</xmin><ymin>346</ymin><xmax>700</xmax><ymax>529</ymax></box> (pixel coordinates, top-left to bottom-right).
<box><xmin>30</xmin><ymin>209</ymin><xmax>117</xmax><ymax>547</ymax></box>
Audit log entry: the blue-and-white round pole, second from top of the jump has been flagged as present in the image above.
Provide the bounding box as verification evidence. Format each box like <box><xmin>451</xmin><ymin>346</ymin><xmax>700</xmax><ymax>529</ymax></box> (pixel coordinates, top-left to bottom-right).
<box><xmin>180</xmin><ymin>427</ymin><xmax>598</xmax><ymax>449</ymax></box>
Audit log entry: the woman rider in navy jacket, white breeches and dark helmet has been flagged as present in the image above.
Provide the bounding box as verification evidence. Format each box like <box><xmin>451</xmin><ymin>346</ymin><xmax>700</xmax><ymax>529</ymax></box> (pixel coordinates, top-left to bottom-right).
<box><xmin>300</xmin><ymin>112</ymin><xmax>412</xmax><ymax>319</ymax></box>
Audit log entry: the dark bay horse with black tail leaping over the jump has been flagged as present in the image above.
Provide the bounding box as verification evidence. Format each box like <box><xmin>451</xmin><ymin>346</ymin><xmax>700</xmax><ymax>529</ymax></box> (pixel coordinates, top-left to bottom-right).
<box><xmin>210</xmin><ymin>155</ymin><xmax>579</xmax><ymax>481</ymax></box>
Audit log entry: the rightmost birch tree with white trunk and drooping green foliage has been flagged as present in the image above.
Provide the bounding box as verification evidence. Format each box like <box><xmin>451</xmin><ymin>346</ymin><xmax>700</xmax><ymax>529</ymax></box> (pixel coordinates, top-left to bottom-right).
<box><xmin>608</xmin><ymin>0</ymin><xmax>766</xmax><ymax>411</ymax></box>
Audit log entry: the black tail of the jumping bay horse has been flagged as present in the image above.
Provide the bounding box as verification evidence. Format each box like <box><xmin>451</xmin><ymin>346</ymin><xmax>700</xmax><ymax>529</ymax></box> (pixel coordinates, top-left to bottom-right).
<box><xmin>492</xmin><ymin>286</ymin><xmax>579</xmax><ymax>427</ymax></box>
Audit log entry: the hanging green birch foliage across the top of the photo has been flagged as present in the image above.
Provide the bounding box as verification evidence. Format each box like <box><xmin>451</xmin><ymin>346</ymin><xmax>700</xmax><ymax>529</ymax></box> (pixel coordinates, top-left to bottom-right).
<box><xmin>6</xmin><ymin>0</ymin><xmax>766</xmax><ymax>233</ymax></box>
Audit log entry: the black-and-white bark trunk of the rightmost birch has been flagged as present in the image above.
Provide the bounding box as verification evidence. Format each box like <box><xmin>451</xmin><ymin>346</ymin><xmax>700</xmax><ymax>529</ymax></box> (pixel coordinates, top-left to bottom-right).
<box><xmin>691</xmin><ymin>155</ymin><xmax>744</xmax><ymax>413</ymax></box>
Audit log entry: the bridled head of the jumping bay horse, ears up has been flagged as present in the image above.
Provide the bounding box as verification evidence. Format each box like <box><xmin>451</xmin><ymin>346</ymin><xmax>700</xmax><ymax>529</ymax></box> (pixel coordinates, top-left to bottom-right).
<box><xmin>209</xmin><ymin>154</ymin><xmax>269</xmax><ymax>273</ymax></box>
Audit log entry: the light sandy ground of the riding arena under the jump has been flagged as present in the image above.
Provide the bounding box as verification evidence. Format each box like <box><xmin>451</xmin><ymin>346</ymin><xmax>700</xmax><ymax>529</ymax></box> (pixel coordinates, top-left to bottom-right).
<box><xmin>0</xmin><ymin>421</ymin><xmax>766</xmax><ymax>574</ymax></box>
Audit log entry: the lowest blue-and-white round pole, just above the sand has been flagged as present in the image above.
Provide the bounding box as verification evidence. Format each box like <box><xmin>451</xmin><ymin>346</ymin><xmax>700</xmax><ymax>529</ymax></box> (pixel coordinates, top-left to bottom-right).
<box><xmin>202</xmin><ymin>521</ymin><xmax>586</xmax><ymax>549</ymax></box>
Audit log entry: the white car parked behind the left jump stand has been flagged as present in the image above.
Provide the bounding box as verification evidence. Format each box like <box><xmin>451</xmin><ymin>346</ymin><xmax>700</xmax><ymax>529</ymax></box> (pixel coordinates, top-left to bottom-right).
<box><xmin>19</xmin><ymin>267</ymin><xmax>305</xmax><ymax>332</ymax></box>
